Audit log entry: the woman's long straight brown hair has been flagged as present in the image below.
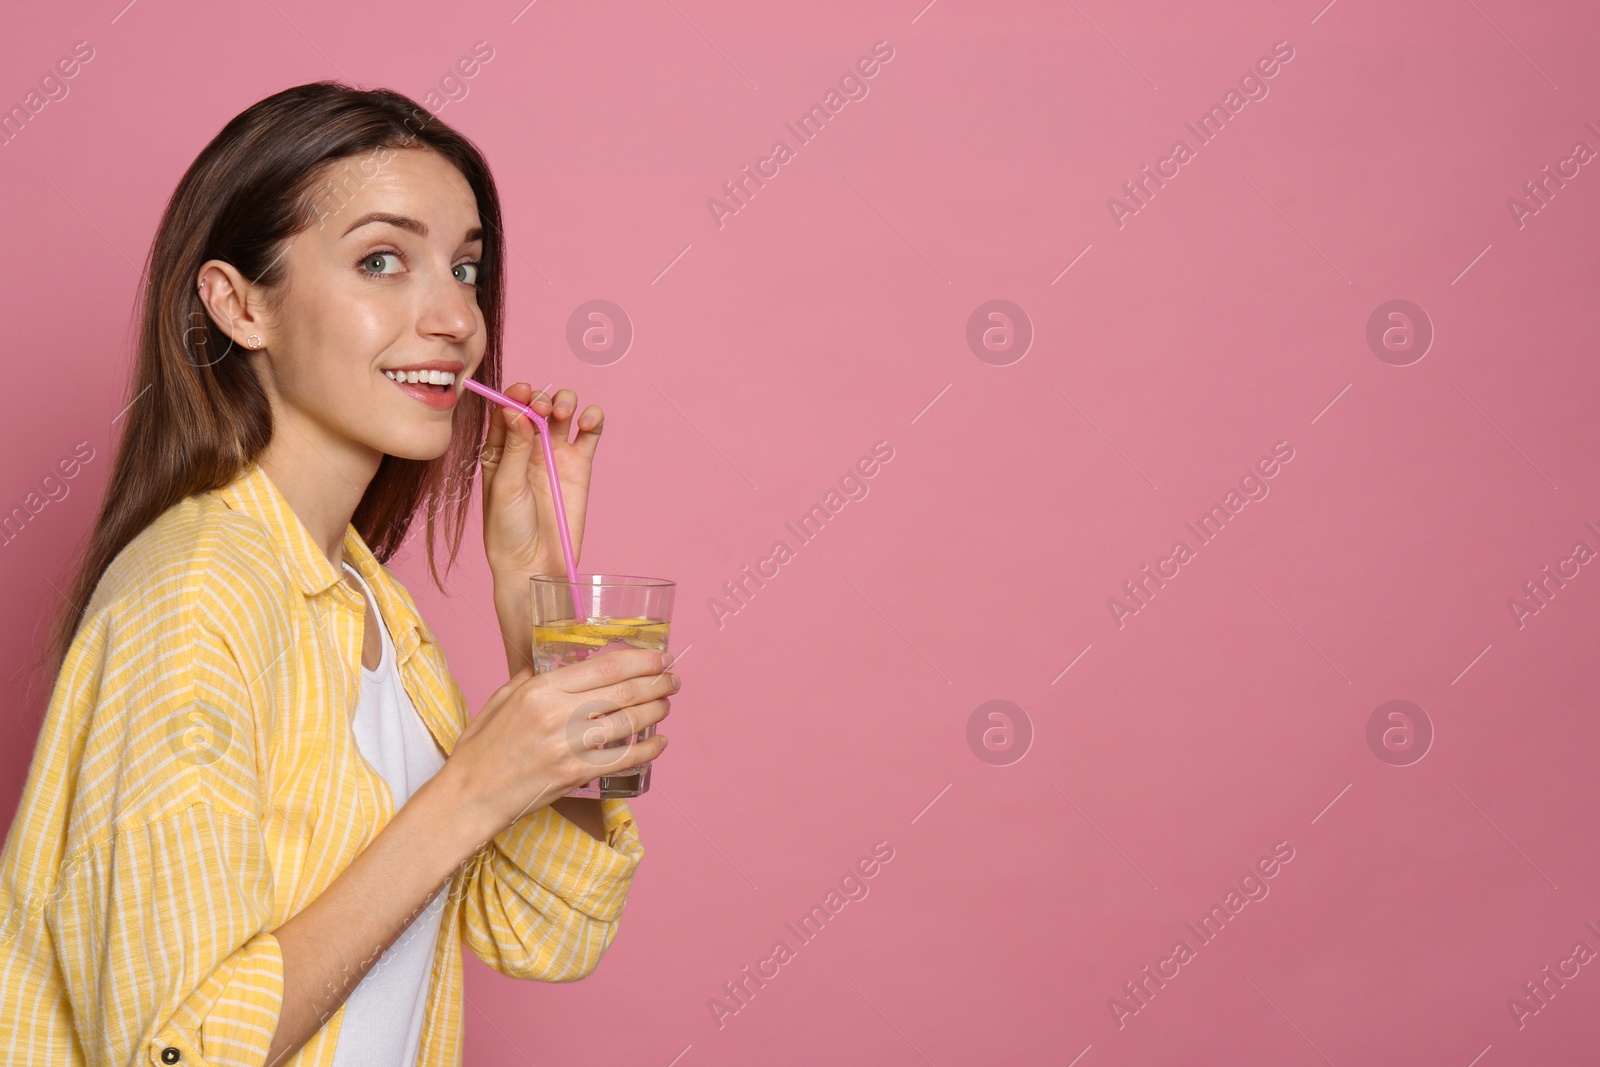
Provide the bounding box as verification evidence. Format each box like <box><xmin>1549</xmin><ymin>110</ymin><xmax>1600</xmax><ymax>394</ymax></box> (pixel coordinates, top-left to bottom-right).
<box><xmin>43</xmin><ymin>82</ymin><xmax>506</xmax><ymax>694</ymax></box>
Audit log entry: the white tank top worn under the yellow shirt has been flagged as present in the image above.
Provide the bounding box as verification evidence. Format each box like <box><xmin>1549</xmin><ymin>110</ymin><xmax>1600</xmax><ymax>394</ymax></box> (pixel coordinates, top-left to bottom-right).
<box><xmin>333</xmin><ymin>563</ymin><xmax>445</xmax><ymax>1067</ymax></box>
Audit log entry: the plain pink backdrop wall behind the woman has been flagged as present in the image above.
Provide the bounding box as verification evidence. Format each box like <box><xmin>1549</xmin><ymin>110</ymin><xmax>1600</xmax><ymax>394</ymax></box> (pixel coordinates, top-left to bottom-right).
<box><xmin>0</xmin><ymin>0</ymin><xmax>1600</xmax><ymax>1067</ymax></box>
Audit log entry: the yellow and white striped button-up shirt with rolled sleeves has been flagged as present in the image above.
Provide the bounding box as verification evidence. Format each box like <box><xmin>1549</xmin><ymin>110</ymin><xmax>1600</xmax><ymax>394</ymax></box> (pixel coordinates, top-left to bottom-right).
<box><xmin>0</xmin><ymin>464</ymin><xmax>645</xmax><ymax>1067</ymax></box>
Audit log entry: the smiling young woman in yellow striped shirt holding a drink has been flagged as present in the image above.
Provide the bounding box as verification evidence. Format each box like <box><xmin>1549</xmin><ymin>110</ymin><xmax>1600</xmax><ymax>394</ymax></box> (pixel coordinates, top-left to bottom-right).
<box><xmin>0</xmin><ymin>83</ymin><xmax>677</xmax><ymax>1067</ymax></box>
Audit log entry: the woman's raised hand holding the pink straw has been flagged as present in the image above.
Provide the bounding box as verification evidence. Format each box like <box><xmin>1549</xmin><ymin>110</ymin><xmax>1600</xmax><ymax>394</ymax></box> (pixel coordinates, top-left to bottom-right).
<box><xmin>480</xmin><ymin>382</ymin><xmax>605</xmax><ymax>595</ymax></box>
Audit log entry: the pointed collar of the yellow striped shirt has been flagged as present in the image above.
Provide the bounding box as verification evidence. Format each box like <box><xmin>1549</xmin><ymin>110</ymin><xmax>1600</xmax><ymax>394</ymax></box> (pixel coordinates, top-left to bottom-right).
<box><xmin>218</xmin><ymin>462</ymin><xmax>432</xmax><ymax>662</ymax></box>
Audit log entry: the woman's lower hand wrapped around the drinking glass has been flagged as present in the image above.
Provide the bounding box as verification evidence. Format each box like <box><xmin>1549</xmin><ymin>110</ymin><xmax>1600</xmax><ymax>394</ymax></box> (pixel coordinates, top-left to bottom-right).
<box><xmin>440</xmin><ymin>648</ymin><xmax>678</xmax><ymax>840</ymax></box>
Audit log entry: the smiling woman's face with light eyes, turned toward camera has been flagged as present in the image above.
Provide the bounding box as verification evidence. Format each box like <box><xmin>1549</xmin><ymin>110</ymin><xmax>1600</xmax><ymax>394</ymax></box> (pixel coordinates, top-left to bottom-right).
<box><xmin>250</xmin><ymin>149</ymin><xmax>486</xmax><ymax>461</ymax></box>
